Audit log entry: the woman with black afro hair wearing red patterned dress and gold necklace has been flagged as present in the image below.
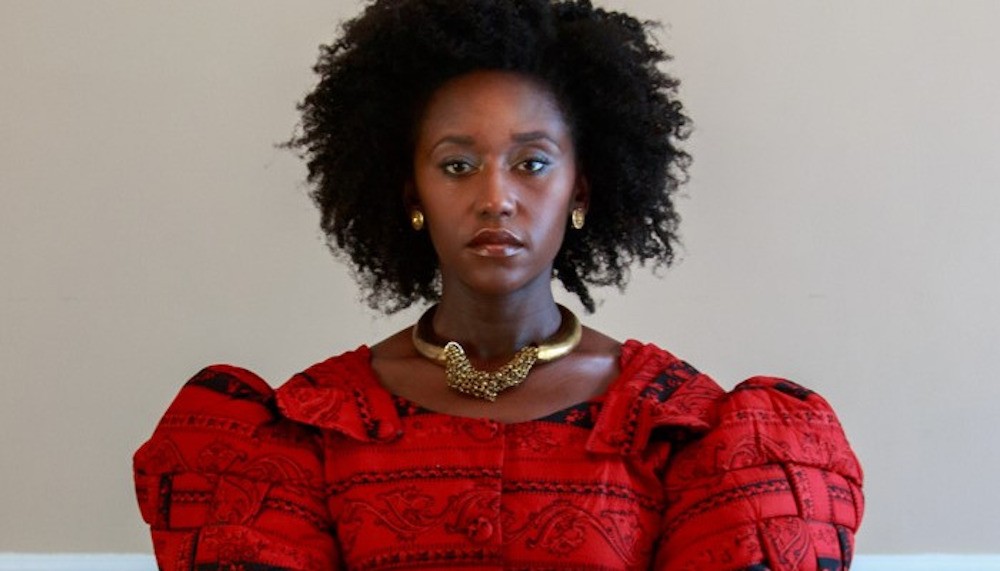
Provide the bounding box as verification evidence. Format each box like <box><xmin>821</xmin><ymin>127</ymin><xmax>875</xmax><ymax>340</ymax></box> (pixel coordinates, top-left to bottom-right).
<box><xmin>135</xmin><ymin>0</ymin><xmax>862</xmax><ymax>571</ymax></box>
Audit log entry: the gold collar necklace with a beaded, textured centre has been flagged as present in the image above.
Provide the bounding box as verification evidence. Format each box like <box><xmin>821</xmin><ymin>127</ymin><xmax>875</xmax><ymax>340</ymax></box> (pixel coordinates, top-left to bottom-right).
<box><xmin>413</xmin><ymin>305</ymin><xmax>582</xmax><ymax>402</ymax></box>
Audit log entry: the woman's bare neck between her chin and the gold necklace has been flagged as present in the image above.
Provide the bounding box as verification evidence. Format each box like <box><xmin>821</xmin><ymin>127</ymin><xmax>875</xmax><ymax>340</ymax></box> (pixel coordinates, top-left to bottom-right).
<box><xmin>433</xmin><ymin>288</ymin><xmax>562</xmax><ymax>364</ymax></box>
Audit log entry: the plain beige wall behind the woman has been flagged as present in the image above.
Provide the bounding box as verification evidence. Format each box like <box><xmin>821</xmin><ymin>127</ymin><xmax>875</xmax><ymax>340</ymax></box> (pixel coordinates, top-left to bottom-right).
<box><xmin>0</xmin><ymin>0</ymin><xmax>1000</xmax><ymax>553</ymax></box>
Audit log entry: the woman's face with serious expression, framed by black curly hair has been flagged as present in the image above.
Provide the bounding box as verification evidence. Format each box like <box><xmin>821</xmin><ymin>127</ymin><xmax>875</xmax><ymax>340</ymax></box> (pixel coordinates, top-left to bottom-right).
<box><xmin>410</xmin><ymin>71</ymin><xmax>587</xmax><ymax>295</ymax></box>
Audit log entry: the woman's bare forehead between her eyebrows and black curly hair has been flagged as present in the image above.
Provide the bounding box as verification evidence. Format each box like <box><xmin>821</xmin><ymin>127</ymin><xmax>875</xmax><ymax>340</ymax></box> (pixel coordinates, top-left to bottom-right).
<box><xmin>418</xmin><ymin>71</ymin><xmax>568</xmax><ymax>143</ymax></box>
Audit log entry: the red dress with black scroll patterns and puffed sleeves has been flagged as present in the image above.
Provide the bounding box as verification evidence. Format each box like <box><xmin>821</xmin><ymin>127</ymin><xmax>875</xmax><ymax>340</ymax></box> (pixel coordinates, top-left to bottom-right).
<box><xmin>135</xmin><ymin>341</ymin><xmax>863</xmax><ymax>571</ymax></box>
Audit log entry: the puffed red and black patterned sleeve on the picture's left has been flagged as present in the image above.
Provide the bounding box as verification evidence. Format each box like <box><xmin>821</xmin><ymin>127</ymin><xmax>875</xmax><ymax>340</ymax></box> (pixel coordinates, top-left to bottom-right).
<box><xmin>133</xmin><ymin>365</ymin><xmax>338</xmax><ymax>571</ymax></box>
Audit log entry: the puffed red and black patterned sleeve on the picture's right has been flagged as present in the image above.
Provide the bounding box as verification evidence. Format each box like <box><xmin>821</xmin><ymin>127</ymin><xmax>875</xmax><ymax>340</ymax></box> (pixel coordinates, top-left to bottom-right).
<box><xmin>655</xmin><ymin>377</ymin><xmax>864</xmax><ymax>571</ymax></box>
